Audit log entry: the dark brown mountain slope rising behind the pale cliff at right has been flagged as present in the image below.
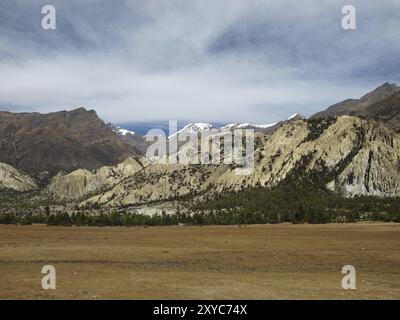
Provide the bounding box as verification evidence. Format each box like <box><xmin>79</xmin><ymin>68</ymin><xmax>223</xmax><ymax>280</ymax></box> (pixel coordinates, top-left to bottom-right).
<box><xmin>312</xmin><ymin>82</ymin><xmax>400</xmax><ymax>132</ymax></box>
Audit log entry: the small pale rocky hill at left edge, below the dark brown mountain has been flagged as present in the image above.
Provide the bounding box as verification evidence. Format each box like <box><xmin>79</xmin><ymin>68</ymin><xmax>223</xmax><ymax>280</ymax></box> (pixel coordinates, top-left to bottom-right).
<box><xmin>0</xmin><ymin>163</ymin><xmax>37</xmax><ymax>191</ymax></box>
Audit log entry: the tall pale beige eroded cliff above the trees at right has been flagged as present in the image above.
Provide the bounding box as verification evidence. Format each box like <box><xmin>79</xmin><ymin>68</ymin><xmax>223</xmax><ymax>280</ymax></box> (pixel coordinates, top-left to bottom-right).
<box><xmin>222</xmin><ymin>116</ymin><xmax>400</xmax><ymax>196</ymax></box>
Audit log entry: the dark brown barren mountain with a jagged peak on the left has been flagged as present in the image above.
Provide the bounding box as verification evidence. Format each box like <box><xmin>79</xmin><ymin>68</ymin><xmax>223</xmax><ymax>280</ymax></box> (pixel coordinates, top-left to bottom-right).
<box><xmin>0</xmin><ymin>108</ymin><xmax>132</xmax><ymax>177</ymax></box>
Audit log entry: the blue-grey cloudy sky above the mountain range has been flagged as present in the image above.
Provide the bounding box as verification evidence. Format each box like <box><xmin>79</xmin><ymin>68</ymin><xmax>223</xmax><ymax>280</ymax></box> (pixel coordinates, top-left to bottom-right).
<box><xmin>0</xmin><ymin>0</ymin><xmax>400</xmax><ymax>123</ymax></box>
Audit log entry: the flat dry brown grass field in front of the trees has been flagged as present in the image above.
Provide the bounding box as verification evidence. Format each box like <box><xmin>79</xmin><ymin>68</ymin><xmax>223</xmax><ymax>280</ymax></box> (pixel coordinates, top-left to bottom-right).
<box><xmin>0</xmin><ymin>223</ymin><xmax>400</xmax><ymax>299</ymax></box>
